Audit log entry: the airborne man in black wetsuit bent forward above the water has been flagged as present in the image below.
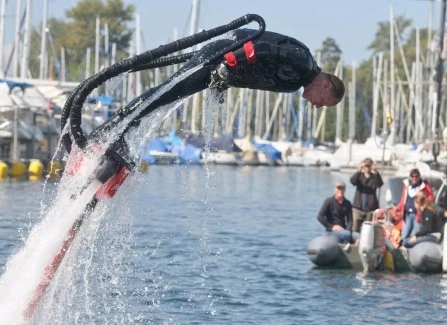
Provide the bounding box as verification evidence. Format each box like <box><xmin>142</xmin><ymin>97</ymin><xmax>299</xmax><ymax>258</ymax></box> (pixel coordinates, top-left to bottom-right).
<box><xmin>113</xmin><ymin>29</ymin><xmax>345</xmax><ymax>129</ymax></box>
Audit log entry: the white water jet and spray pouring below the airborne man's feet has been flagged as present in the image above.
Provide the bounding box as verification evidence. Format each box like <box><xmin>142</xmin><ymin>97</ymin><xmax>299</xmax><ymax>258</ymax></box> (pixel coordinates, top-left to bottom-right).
<box><xmin>0</xmin><ymin>62</ymin><xmax>224</xmax><ymax>324</ymax></box>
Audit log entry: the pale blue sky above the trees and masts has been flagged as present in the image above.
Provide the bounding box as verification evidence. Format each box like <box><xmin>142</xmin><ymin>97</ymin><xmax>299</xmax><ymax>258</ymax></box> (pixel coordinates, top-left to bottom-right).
<box><xmin>0</xmin><ymin>0</ymin><xmax>441</xmax><ymax>65</ymax></box>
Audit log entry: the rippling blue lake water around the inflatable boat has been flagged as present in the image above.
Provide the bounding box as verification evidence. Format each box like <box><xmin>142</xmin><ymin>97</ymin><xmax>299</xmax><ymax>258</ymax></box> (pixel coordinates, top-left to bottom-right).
<box><xmin>0</xmin><ymin>165</ymin><xmax>447</xmax><ymax>325</ymax></box>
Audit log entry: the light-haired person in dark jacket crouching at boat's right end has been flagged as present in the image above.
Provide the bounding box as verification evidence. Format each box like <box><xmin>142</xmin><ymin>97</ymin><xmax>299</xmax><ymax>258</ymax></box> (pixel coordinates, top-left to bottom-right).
<box><xmin>404</xmin><ymin>193</ymin><xmax>447</xmax><ymax>248</ymax></box>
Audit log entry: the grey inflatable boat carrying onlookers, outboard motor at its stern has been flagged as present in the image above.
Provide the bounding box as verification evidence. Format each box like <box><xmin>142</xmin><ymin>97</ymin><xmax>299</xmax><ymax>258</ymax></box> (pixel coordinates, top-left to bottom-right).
<box><xmin>307</xmin><ymin>209</ymin><xmax>447</xmax><ymax>273</ymax></box>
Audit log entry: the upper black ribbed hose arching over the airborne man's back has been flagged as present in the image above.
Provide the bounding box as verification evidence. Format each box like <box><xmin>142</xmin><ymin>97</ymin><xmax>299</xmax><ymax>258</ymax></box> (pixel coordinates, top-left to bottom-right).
<box><xmin>65</xmin><ymin>14</ymin><xmax>265</xmax><ymax>150</ymax></box>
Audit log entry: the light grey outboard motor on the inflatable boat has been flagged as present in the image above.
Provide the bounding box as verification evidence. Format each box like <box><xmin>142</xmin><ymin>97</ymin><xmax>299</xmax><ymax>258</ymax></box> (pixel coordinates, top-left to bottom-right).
<box><xmin>359</xmin><ymin>221</ymin><xmax>386</xmax><ymax>272</ymax></box>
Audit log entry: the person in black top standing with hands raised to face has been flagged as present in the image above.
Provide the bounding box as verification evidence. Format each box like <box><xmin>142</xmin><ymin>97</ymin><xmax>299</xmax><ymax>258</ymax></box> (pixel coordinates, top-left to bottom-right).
<box><xmin>350</xmin><ymin>158</ymin><xmax>383</xmax><ymax>232</ymax></box>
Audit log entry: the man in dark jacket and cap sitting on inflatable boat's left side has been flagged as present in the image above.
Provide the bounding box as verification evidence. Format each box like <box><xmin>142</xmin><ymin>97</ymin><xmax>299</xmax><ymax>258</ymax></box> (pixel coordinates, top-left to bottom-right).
<box><xmin>317</xmin><ymin>181</ymin><xmax>360</xmax><ymax>244</ymax></box>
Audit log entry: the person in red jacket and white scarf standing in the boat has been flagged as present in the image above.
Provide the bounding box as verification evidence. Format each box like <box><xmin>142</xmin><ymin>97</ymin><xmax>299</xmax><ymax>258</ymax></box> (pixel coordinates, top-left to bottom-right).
<box><xmin>396</xmin><ymin>168</ymin><xmax>434</xmax><ymax>245</ymax></box>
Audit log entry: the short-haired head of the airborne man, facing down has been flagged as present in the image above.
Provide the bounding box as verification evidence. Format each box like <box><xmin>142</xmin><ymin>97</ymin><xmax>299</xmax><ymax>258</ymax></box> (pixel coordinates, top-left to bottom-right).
<box><xmin>303</xmin><ymin>71</ymin><xmax>345</xmax><ymax>108</ymax></box>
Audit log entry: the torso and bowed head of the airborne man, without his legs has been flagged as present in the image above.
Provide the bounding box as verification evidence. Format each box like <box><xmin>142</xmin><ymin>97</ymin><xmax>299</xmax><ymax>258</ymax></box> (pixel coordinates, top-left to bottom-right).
<box><xmin>204</xmin><ymin>29</ymin><xmax>344</xmax><ymax>107</ymax></box>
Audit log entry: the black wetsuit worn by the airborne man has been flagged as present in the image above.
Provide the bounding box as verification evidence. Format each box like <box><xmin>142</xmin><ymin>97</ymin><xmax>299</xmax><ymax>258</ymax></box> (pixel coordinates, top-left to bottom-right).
<box><xmin>93</xmin><ymin>29</ymin><xmax>321</xmax><ymax>134</ymax></box>
